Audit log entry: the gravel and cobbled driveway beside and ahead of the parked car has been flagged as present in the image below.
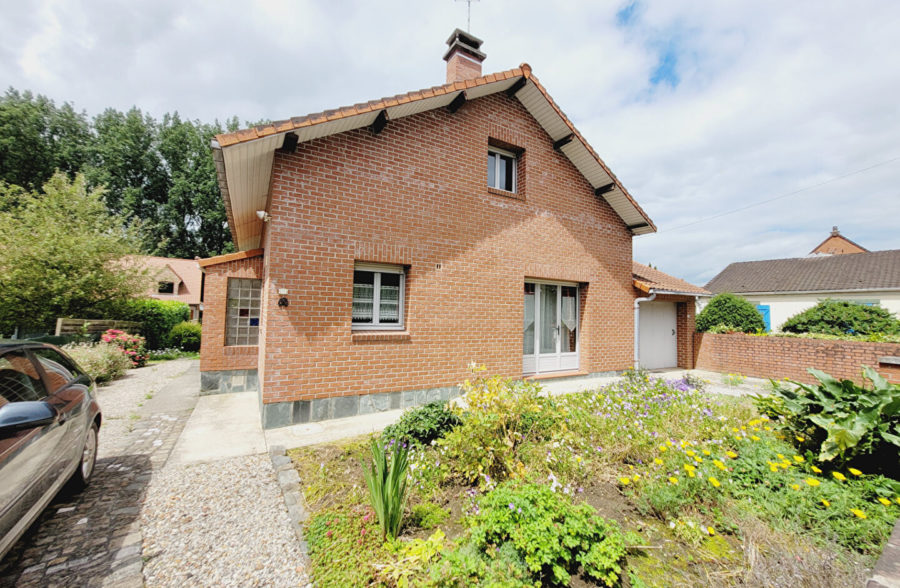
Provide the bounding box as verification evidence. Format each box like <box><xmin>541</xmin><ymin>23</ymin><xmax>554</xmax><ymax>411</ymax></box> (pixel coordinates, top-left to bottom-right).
<box><xmin>0</xmin><ymin>360</ymin><xmax>308</xmax><ymax>587</ymax></box>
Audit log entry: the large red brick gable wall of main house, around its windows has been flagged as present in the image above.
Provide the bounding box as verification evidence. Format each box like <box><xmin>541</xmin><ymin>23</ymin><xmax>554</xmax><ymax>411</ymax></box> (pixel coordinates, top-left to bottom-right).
<box><xmin>248</xmin><ymin>95</ymin><xmax>633</xmax><ymax>402</ymax></box>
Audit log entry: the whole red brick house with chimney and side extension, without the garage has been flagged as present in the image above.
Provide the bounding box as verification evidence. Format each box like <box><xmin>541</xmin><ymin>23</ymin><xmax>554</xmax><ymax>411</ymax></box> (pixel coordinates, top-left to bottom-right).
<box><xmin>199</xmin><ymin>30</ymin><xmax>693</xmax><ymax>428</ymax></box>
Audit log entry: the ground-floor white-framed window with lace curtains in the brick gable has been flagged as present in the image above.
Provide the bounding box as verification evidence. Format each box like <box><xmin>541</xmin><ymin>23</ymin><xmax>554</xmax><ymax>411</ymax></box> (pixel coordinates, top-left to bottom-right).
<box><xmin>353</xmin><ymin>263</ymin><xmax>406</xmax><ymax>330</ymax></box>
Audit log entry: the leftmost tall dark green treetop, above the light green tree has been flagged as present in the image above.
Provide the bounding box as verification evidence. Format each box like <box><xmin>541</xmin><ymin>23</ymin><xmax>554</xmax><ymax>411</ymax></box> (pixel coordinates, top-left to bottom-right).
<box><xmin>0</xmin><ymin>88</ymin><xmax>93</xmax><ymax>190</ymax></box>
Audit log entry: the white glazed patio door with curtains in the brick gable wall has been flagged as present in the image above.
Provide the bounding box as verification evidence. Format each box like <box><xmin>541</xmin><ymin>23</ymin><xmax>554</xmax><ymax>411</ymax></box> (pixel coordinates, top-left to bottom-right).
<box><xmin>522</xmin><ymin>281</ymin><xmax>579</xmax><ymax>374</ymax></box>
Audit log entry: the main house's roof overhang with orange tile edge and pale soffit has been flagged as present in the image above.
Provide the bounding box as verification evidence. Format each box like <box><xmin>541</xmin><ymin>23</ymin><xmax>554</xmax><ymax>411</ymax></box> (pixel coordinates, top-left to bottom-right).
<box><xmin>213</xmin><ymin>63</ymin><xmax>656</xmax><ymax>250</ymax></box>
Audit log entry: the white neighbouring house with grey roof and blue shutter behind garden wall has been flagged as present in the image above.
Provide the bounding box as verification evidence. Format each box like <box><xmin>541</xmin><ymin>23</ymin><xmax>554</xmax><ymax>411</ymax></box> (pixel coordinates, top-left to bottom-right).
<box><xmin>700</xmin><ymin>227</ymin><xmax>900</xmax><ymax>331</ymax></box>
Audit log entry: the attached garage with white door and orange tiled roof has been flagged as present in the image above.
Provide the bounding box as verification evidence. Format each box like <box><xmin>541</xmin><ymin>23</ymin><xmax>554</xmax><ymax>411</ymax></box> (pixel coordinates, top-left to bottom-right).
<box><xmin>631</xmin><ymin>261</ymin><xmax>710</xmax><ymax>370</ymax></box>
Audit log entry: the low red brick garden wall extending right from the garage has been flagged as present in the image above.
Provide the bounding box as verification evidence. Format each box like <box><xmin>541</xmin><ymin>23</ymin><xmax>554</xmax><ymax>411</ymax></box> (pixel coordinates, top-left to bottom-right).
<box><xmin>694</xmin><ymin>333</ymin><xmax>900</xmax><ymax>384</ymax></box>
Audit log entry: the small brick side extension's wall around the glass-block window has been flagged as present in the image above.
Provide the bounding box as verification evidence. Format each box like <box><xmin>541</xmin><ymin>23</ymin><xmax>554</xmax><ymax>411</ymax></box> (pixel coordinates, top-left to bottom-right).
<box><xmin>200</xmin><ymin>257</ymin><xmax>263</xmax><ymax>372</ymax></box>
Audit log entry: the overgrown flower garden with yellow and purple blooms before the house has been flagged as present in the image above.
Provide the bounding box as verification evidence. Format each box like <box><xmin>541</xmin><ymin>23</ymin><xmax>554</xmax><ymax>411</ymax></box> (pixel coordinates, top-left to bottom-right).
<box><xmin>290</xmin><ymin>373</ymin><xmax>900</xmax><ymax>587</ymax></box>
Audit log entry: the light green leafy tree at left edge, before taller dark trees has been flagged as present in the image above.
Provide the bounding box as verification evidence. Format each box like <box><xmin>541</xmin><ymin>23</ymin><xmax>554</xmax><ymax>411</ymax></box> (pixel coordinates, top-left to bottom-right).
<box><xmin>0</xmin><ymin>173</ymin><xmax>149</xmax><ymax>334</ymax></box>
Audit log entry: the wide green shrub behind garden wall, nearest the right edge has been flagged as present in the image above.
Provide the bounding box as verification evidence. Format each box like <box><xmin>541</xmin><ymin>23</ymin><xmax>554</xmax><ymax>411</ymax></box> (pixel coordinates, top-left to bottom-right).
<box><xmin>781</xmin><ymin>300</ymin><xmax>900</xmax><ymax>335</ymax></box>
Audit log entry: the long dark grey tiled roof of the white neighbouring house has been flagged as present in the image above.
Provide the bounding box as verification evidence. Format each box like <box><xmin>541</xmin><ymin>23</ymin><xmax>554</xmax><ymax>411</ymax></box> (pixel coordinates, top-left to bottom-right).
<box><xmin>706</xmin><ymin>249</ymin><xmax>900</xmax><ymax>294</ymax></box>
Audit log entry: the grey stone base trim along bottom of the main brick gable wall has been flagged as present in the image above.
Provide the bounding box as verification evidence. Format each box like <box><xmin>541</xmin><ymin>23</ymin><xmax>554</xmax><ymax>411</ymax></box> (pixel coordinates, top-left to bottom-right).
<box><xmin>258</xmin><ymin>386</ymin><xmax>461</xmax><ymax>429</ymax></box>
